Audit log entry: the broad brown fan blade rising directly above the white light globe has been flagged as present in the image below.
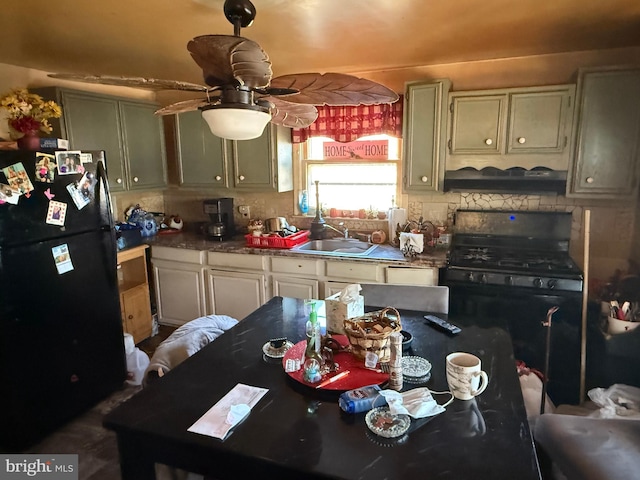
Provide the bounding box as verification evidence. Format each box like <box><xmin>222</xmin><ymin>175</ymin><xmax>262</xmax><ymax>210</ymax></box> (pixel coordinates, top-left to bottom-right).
<box><xmin>187</xmin><ymin>35</ymin><xmax>273</xmax><ymax>88</ymax></box>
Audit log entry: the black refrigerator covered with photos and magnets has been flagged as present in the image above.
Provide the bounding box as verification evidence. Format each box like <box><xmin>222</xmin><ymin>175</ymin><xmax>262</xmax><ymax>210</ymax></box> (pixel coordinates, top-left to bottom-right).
<box><xmin>0</xmin><ymin>150</ymin><xmax>126</xmax><ymax>452</ymax></box>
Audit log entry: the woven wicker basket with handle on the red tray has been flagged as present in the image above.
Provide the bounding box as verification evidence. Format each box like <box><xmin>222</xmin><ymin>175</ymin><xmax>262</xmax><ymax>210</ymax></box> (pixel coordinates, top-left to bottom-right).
<box><xmin>344</xmin><ymin>307</ymin><xmax>402</xmax><ymax>362</ymax></box>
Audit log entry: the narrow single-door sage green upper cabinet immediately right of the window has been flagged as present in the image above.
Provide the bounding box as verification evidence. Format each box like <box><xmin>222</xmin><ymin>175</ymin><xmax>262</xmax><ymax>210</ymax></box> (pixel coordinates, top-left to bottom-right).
<box><xmin>402</xmin><ymin>80</ymin><xmax>451</xmax><ymax>191</ymax></box>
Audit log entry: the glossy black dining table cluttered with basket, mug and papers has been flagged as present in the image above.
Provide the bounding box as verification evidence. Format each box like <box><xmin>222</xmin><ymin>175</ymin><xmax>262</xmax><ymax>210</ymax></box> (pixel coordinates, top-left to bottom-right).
<box><xmin>104</xmin><ymin>297</ymin><xmax>540</xmax><ymax>480</ymax></box>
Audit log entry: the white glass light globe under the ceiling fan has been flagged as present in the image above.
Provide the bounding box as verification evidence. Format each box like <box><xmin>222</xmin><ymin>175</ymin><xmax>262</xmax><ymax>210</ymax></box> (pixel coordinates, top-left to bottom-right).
<box><xmin>202</xmin><ymin>105</ymin><xmax>271</xmax><ymax>140</ymax></box>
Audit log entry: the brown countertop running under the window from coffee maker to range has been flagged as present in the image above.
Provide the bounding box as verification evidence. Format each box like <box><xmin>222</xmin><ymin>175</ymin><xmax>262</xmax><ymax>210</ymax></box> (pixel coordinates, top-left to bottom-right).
<box><xmin>143</xmin><ymin>232</ymin><xmax>447</xmax><ymax>268</ymax></box>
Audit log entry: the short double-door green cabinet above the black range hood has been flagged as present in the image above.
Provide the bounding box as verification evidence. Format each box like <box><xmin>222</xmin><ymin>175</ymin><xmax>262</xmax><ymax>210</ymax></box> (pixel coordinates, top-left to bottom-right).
<box><xmin>446</xmin><ymin>85</ymin><xmax>575</xmax><ymax>170</ymax></box>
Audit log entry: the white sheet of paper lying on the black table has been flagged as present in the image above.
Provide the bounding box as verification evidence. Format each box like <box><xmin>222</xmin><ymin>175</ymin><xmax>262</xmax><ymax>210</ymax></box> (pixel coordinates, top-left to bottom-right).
<box><xmin>187</xmin><ymin>383</ymin><xmax>269</xmax><ymax>440</ymax></box>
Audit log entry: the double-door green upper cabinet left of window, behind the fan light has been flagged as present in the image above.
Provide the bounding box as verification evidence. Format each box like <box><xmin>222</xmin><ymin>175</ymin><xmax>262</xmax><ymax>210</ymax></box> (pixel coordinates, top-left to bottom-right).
<box><xmin>176</xmin><ymin>112</ymin><xmax>293</xmax><ymax>192</ymax></box>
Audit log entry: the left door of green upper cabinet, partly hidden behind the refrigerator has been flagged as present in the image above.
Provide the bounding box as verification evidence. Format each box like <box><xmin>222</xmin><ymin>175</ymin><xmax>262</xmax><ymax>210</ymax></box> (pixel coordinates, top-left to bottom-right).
<box><xmin>61</xmin><ymin>91</ymin><xmax>126</xmax><ymax>192</ymax></box>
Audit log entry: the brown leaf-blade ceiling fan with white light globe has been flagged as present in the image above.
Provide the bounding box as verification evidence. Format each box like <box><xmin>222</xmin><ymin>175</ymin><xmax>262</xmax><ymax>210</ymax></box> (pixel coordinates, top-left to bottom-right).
<box><xmin>49</xmin><ymin>0</ymin><xmax>398</xmax><ymax>140</ymax></box>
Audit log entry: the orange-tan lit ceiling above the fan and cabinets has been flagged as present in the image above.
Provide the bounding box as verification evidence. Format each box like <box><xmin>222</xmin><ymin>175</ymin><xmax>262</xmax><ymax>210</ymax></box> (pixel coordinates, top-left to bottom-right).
<box><xmin>0</xmin><ymin>0</ymin><xmax>640</xmax><ymax>93</ymax></box>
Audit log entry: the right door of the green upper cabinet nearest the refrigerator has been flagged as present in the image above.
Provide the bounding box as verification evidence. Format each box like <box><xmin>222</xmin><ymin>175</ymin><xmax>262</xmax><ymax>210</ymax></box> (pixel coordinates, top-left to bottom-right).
<box><xmin>120</xmin><ymin>102</ymin><xmax>167</xmax><ymax>190</ymax></box>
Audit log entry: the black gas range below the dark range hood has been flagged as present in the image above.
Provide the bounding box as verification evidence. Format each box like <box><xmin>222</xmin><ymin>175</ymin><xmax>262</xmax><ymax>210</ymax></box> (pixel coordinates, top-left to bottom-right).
<box><xmin>443</xmin><ymin>210</ymin><xmax>583</xmax><ymax>403</ymax></box>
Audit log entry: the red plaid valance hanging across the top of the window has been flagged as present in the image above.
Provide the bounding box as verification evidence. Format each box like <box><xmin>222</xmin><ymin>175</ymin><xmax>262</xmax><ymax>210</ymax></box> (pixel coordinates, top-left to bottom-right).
<box><xmin>291</xmin><ymin>96</ymin><xmax>403</xmax><ymax>143</ymax></box>
